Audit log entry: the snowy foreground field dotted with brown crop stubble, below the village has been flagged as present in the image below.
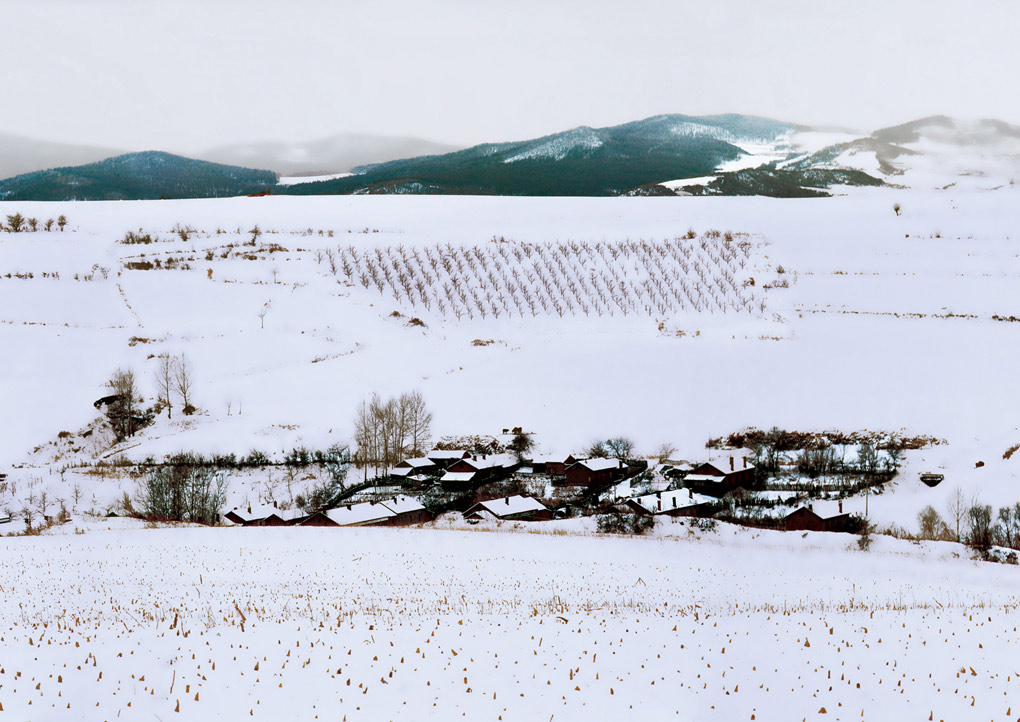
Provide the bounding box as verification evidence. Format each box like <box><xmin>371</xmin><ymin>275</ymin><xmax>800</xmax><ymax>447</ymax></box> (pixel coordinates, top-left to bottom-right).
<box><xmin>0</xmin><ymin>521</ymin><xmax>1020</xmax><ymax>721</ymax></box>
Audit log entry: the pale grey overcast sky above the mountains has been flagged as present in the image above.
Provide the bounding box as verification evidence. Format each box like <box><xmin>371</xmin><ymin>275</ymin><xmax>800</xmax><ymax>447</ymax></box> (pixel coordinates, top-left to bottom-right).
<box><xmin>0</xmin><ymin>0</ymin><xmax>1020</xmax><ymax>152</ymax></box>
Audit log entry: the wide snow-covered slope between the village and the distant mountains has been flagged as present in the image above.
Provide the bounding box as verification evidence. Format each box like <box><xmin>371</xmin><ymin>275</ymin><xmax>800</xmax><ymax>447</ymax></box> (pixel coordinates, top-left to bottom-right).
<box><xmin>0</xmin><ymin>187</ymin><xmax>1020</xmax><ymax>523</ymax></box>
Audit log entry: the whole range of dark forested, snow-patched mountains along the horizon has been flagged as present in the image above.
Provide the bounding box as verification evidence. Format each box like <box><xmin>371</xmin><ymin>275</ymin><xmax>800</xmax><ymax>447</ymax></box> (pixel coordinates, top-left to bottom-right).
<box><xmin>0</xmin><ymin>115</ymin><xmax>1020</xmax><ymax>200</ymax></box>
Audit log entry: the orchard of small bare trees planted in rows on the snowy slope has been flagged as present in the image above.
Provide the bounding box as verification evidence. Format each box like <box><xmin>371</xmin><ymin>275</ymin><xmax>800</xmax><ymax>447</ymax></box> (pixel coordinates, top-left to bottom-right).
<box><xmin>318</xmin><ymin>230</ymin><xmax>765</xmax><ymax>320</ymax></box>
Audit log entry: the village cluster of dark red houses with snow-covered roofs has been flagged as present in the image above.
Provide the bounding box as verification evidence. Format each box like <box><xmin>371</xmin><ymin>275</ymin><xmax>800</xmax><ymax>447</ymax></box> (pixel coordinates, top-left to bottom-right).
<box><xmin>222</xmin><ymin>429</ymin><xmax>864</xmax><ymax>531</ymax></box>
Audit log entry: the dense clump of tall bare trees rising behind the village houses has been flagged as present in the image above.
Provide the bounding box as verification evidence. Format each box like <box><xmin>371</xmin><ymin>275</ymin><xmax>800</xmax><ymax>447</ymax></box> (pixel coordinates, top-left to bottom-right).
<box><xmin>354</xmin><ymin>392</ymin><xmax>432</xmax><ymax>478</ymax></box>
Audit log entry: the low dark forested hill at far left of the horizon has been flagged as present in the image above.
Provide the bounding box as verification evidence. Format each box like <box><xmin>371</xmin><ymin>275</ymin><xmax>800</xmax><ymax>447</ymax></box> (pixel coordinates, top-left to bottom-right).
<box><xmin>0</xmin><ymin>151</ymin><xmax>276</xmax><ymax>201</ymax></box>
